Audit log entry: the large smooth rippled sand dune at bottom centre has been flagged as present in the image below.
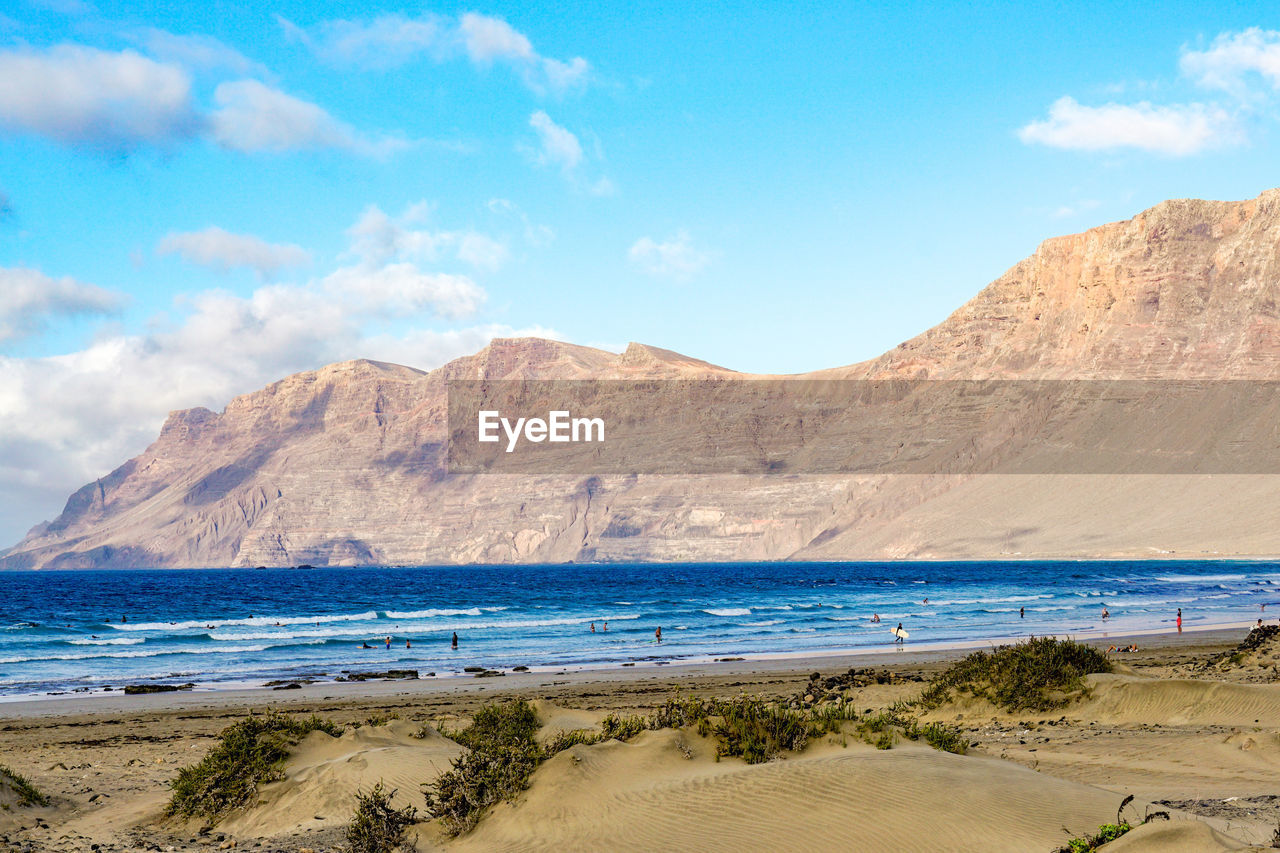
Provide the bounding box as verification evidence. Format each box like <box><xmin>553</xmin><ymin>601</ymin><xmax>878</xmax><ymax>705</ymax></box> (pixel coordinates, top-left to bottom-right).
<box><xmin>440</xmin><ymin>730</ymin><xmax>1119</xmax><ymax>853</ymax></box>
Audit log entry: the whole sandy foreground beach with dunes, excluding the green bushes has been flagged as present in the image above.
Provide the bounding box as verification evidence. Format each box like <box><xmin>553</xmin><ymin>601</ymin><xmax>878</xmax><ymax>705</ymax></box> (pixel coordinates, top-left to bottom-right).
<box><xmin>0</xmin><ymin>629</ymin><xmax>1280</xmax><ymax>853</ymax></box>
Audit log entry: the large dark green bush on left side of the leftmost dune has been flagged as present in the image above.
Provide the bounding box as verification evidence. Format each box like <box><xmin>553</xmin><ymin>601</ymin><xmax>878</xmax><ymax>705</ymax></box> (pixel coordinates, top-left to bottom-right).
<box><xmin>165</xmin><ymin>711</ymin><xmax>342</xmax><ymax>820</ymax></box>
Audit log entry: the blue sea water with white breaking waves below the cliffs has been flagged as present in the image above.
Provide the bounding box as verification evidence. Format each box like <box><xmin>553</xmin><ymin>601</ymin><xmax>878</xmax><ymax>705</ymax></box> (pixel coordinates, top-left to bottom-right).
<box><xmin>0</xmin><ymin>561</ymin><xmax>1280</xmax><ymax>698</ymax></box>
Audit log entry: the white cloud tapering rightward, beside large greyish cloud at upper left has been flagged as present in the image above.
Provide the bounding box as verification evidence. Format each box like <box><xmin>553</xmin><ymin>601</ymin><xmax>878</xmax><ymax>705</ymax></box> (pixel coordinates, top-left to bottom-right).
<box><xmin>210</xmin><ymin>79</ymin><xmax>406</xmax><ymax>155</ymax></box>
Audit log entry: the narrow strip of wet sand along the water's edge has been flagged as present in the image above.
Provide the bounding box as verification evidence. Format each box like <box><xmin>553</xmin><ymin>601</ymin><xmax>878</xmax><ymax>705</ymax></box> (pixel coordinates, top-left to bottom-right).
<box><xmin>0</xmin><ymin>622</ymin><xmax>1254</xmax><ymax>720</ymax></box>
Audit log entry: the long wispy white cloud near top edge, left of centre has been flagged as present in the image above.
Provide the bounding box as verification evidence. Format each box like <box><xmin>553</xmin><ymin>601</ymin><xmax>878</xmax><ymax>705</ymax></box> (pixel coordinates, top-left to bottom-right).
<box><xmin>276</xmin><ymin>12</ymin><xmax>591</xmax><ymax>93</ymax></box>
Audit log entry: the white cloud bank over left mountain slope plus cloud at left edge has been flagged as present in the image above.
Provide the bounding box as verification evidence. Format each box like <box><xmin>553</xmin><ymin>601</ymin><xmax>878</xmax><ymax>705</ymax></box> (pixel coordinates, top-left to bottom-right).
<box><xmin>0</xmin><ymin>198</ymin><xmax>545</xmax><ymax>537</ymax></box>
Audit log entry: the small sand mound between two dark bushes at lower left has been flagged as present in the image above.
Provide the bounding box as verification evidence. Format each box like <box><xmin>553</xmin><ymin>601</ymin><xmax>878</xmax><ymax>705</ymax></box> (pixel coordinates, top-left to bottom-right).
<box><xmin>219</xmin><ymin>720</ymin><xmax>462</xmax><ymax>838</ymax></box>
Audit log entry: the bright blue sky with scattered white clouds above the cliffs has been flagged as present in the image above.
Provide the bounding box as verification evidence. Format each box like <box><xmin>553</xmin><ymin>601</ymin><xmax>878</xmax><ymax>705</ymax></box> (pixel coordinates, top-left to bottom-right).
<box><xmin>0</xmin><ymin>0</ymin><xmax>1280</xmax><ymax>540</ymax></box>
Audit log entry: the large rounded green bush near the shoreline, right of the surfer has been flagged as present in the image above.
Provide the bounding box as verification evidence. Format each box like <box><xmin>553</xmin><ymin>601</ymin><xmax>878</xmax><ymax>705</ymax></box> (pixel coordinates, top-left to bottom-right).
<box><xmin>918</xmin><ymin>637</ymin><xmax>1112</xmax><ymax>712</ymax></box>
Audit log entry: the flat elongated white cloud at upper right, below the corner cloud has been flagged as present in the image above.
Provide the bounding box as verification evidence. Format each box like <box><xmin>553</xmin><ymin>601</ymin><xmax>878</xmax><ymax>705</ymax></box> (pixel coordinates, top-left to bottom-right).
<box><xmin>1018</xmin><ymin>97</ymin><xmax>1239</xmax><ymax>156</ymax></box>
